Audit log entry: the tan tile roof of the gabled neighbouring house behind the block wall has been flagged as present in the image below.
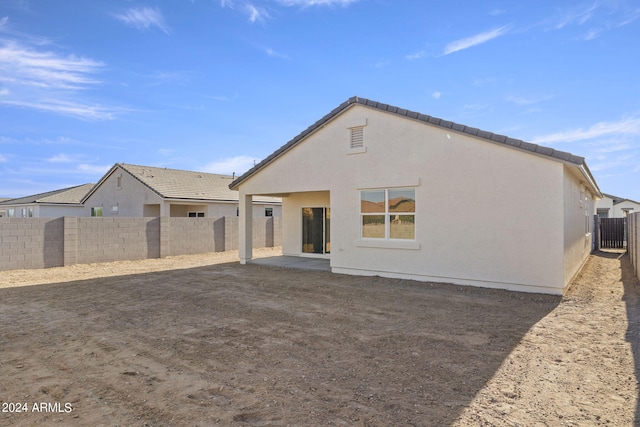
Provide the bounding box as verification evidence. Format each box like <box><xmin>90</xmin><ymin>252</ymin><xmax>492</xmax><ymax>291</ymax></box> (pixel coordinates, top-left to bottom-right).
<box><xmin>83</xmin><ymin>163</ymin><xmax>281</xmax><ymax>203</ymax></box>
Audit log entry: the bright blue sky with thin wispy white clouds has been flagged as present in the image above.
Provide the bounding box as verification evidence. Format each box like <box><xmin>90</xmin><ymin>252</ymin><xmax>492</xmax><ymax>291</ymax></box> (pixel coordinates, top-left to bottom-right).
<box><xmin>0</xmin><ymin>0</ymin><xmax>640</xmax><ymax>201</ymax></box>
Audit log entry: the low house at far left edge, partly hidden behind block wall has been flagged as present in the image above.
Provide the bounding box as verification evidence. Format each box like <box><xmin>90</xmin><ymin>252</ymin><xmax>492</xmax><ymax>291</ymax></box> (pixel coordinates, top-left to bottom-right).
<box><xmin>0</xmin><ymin>184</ymin><xmax>93</xmax><ymax>218</ymax></box>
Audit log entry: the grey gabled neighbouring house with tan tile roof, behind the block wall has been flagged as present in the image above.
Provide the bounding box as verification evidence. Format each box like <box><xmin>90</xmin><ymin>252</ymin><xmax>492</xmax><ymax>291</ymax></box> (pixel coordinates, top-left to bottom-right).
<box><xmin>82</xmin><ymin>163</ymin><xmax>282</xmax><ymax>217</ymax></box>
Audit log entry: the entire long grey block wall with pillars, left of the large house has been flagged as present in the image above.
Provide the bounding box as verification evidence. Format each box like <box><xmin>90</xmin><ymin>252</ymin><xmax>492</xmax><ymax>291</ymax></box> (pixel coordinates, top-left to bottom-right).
<box><xmin>0</xmin><ymin>217</ymin><xmax>282</xmax><ymax>270</ymax></box>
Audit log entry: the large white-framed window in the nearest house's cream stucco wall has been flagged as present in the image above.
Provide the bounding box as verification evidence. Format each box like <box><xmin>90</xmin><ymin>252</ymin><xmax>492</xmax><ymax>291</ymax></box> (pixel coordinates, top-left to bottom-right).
<box><xmin>360</xmin><ymin>188</ymin><xmax>416</xmax><ymax>240</ymax></box>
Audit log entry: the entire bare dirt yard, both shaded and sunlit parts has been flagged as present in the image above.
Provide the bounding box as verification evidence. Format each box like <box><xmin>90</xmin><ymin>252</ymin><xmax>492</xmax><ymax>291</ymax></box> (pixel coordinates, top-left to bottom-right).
<box><xmin>0</xmin><ymin>250</ymin><xmax>640</xmax><ymax>426</ymax></box>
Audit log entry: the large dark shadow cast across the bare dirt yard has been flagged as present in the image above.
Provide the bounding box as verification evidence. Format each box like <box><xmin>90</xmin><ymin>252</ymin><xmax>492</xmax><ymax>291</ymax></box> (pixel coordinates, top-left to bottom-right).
<box><xmin>0</xmin><ymin>263</ymin><xmax>560</xmax><ymax>426</ymax></box>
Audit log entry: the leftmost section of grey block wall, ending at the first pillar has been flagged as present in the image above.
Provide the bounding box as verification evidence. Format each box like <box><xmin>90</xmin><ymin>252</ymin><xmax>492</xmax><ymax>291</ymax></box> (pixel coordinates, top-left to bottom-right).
<box><xmin>0</xmin><ymin>218</ymin><xmax>64</xmax><ymax>270</ymax></box>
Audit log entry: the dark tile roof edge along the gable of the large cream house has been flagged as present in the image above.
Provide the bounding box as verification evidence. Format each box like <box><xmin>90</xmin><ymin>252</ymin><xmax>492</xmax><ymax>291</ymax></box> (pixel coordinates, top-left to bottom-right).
<box><xmin>229</xmin><ymin>96</ymin><xmax>601</xmax><ymax>196</ymax></box>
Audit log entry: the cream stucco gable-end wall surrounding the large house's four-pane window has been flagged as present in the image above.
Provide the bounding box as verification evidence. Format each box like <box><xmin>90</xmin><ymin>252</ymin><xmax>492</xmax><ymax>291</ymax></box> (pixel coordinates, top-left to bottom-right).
<box><xmin>240</xmin><ymin>106</ymin><xmax>576</xmax><ymax>293</ymax></box>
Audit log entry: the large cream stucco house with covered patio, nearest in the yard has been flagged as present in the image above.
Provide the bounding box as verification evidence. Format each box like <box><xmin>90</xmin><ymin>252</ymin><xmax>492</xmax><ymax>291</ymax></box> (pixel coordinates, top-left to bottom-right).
<box><xmin>230</xmin><ymin>97</ymin><xmax>602</xmax><ymax>294</ymax></box>
